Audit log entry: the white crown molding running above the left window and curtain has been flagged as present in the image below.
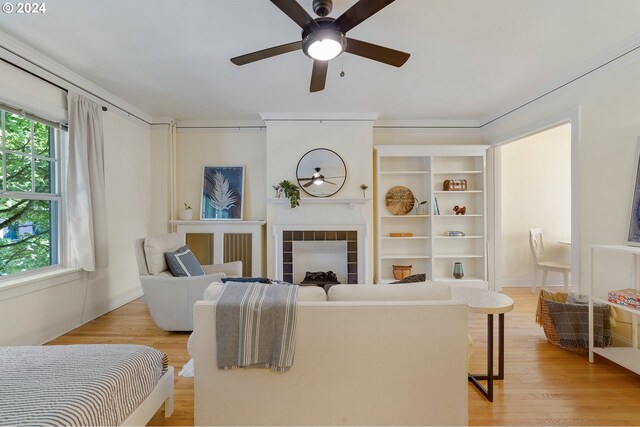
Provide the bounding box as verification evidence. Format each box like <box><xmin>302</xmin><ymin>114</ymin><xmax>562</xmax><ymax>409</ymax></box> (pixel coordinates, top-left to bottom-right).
<box><xmin>0</xmin><ymin>31</ymin><xmax>152</xmax><ymax>125</ymax></box>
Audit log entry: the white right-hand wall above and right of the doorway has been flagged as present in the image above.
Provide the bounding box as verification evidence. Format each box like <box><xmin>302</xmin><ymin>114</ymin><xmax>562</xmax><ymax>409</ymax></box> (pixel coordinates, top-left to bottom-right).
<box><xmin>484</xmin><ymin>49</ymin><xmax>640</xmax><ymax>292</ymax></box>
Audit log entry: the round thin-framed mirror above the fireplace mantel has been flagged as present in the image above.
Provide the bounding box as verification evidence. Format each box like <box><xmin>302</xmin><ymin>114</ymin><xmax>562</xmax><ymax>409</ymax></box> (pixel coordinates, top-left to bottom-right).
<box><xmin>296</xmin><ymin>148</ymin><xmax>347</xmax><ymax>197</ymax></box>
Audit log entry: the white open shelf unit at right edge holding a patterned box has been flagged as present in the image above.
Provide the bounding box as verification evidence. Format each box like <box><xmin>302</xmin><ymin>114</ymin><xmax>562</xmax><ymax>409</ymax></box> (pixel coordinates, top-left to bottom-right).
<box><xmin>589</xmin><ymin>245</ymin><xmax>640</xmax><ymax>374</ymax></box>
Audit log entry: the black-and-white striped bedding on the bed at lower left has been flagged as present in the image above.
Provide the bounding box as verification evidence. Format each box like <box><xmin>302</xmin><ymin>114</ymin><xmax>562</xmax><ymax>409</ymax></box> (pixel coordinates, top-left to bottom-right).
<box><xmin>0</xmin><ymin>344</ymin><xmax>168</xmax><ymax>426</ymax></box>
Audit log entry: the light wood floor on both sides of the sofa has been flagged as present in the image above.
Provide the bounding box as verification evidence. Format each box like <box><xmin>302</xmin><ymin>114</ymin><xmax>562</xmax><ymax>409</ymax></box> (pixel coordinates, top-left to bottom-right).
<box><xmin>50</xmin><ymin>288</ymin><xmax>640</xmax><ymax>425</ymax></box>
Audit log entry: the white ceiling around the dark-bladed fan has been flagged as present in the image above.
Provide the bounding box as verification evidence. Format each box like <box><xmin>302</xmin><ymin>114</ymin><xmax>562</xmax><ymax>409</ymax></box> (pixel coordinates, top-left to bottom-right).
<box><xmin>0</xmin><ymin>0</ymin><xmax>640</xmax><ymax>120</ymax></box>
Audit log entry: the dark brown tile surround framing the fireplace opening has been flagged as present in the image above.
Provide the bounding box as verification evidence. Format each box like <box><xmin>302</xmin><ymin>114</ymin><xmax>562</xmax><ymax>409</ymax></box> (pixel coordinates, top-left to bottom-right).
<box><xmin>281</xmin><ymin>230</ymin><xmax>358</xmax><ymax>284</ymax></box>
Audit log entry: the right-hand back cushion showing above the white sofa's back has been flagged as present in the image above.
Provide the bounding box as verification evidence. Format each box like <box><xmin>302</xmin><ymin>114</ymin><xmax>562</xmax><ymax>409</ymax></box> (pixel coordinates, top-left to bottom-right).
<box><xmin>327</xmin><ymin>283</ymin><xmax>451</xmax><ymax>301</ymax></box>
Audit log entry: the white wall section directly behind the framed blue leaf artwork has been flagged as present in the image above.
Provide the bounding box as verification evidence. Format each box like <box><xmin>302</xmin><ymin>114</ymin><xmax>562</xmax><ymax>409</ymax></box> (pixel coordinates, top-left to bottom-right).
<box><xmin>174</xmin><ymin>126</ymin><xmax>266</xmax><ymax>220</ymax></box>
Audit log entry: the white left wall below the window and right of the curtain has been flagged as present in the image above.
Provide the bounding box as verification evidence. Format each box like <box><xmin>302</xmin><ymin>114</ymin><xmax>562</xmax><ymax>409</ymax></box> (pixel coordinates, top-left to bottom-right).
<box><xmin>0</xmin><ymin>62</ymin><xmax>154</xmax><ymax>345</ymax></box>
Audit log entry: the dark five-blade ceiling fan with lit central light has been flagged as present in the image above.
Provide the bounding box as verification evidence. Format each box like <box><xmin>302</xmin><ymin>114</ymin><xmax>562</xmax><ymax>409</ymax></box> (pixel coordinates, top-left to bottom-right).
<box><xmin>231</xmin><ymin>0</ymin><xmax>410</xmax><ymax>92</ymax></box>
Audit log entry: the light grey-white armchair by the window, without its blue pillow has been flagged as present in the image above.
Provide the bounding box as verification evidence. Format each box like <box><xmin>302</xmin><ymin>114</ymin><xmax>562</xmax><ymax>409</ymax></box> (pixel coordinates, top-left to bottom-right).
<box><xmin>134</xmin><ymin>233</ymin><xmax>242</xmax><ymax>331</ymax></box>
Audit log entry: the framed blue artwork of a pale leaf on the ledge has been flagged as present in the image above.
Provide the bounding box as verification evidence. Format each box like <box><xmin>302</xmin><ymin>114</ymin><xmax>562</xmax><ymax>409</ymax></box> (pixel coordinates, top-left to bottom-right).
<box><xmin>200</xmin><ymin>166</ymin><xmax>244</xmax><ymax>220</ymax></box>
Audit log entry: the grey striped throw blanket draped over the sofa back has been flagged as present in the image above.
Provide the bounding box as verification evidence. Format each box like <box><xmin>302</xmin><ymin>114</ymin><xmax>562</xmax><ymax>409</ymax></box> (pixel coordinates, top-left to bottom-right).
<box><xmin>216</xmin><ymin>282</ymin><xmax>298</xmax><ymax>372</ymax></box>
